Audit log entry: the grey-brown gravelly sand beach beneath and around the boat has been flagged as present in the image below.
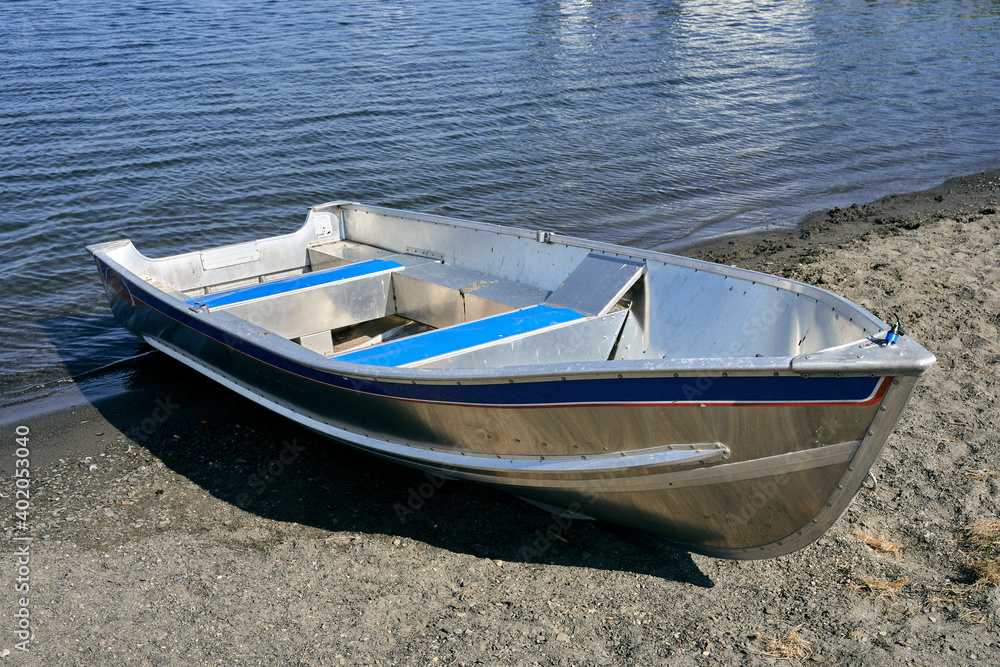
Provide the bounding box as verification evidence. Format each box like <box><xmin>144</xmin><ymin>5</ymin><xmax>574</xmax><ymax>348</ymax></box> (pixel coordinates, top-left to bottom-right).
<box><xmin>0</xmin><ymin>172</ymin><xmax>1000</xmax><ymax>666</ymax></box>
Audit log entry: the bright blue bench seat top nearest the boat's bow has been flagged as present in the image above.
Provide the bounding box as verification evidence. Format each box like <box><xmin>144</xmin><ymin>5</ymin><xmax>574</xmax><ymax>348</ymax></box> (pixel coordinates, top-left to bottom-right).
<box><xmin>335</xmin><ymin>304</ymin><xmax>586</xmax><ymax>366</ymax></box>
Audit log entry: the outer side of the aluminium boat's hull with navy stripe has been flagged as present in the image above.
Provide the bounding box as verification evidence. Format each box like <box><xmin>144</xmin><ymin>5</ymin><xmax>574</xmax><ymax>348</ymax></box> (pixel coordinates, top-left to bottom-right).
<box><xmin>98</xmin><ymin>257</ymin><xmax>916</xmax><ymax>559</ymax></box>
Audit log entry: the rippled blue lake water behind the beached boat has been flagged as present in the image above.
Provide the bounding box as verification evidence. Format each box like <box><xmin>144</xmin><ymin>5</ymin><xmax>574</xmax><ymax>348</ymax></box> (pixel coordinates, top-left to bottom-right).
<box><xmin>0</xmin><ymin>0</ymin><xmax>1000</xmax><ymax>407</ymax></box>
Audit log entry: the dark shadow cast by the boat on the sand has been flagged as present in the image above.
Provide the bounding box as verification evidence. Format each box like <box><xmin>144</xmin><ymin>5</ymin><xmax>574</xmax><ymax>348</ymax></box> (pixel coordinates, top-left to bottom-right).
<box><xmin>50</xmin><ymin>332</ymin><xmax>714</xmax><ymax>588</ymax></box>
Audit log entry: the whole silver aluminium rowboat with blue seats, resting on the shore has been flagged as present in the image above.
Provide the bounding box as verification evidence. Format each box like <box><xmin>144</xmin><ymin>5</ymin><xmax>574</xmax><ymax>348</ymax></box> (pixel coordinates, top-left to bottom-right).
<box><xmin>88</xmin><ymin>201</ymin><xmax>934</xmax><ymax>559</ymax></box>
